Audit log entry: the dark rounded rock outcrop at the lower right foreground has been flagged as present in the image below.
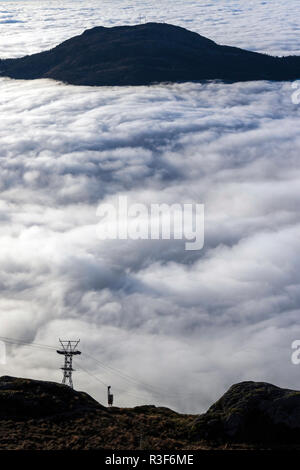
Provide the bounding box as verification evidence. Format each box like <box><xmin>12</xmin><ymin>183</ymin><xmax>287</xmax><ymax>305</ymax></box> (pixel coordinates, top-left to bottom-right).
<box><xmin>193</xmin><ymin>382</ymin><xmax>300</xmax><ymax>445</ymax></box>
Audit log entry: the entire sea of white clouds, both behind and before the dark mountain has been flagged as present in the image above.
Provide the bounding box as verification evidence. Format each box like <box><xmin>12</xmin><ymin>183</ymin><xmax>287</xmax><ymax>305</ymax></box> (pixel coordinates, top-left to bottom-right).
<box><xmin>0</xmin><ymin>0</ymin><xmax>300</xmax><ymax>413</ymax></box>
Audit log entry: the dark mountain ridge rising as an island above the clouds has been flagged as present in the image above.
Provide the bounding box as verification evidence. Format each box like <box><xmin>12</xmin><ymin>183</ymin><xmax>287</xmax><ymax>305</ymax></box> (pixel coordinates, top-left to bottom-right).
<box><xmin>0</xmin><ymin>23</ymin><xmax>300</xmax><ymax>86</ymax></box>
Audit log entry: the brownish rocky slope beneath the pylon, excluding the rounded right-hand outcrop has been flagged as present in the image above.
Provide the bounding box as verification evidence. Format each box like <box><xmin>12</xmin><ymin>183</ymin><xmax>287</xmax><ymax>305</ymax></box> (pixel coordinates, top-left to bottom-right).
<box><xmin>0</xmin><ymin>377</ymin><xmax>195</xmax><ymax>450</ymax></box>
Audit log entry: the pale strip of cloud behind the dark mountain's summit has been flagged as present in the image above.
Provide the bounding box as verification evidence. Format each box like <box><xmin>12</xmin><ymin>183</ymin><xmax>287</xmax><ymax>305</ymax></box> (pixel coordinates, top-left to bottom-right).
<box><xmin>0</xmin><ymin>0</ymin><xmax>300</xmax><ymax>58</ymax></box>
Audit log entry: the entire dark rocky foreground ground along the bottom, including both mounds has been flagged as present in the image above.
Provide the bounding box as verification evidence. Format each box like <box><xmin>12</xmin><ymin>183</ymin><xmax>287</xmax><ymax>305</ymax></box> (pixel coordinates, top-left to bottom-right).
<box><xmin>0</xmin><ymin>376</ymin><xmax>300</xmax><ymax>450</ymax></box>
